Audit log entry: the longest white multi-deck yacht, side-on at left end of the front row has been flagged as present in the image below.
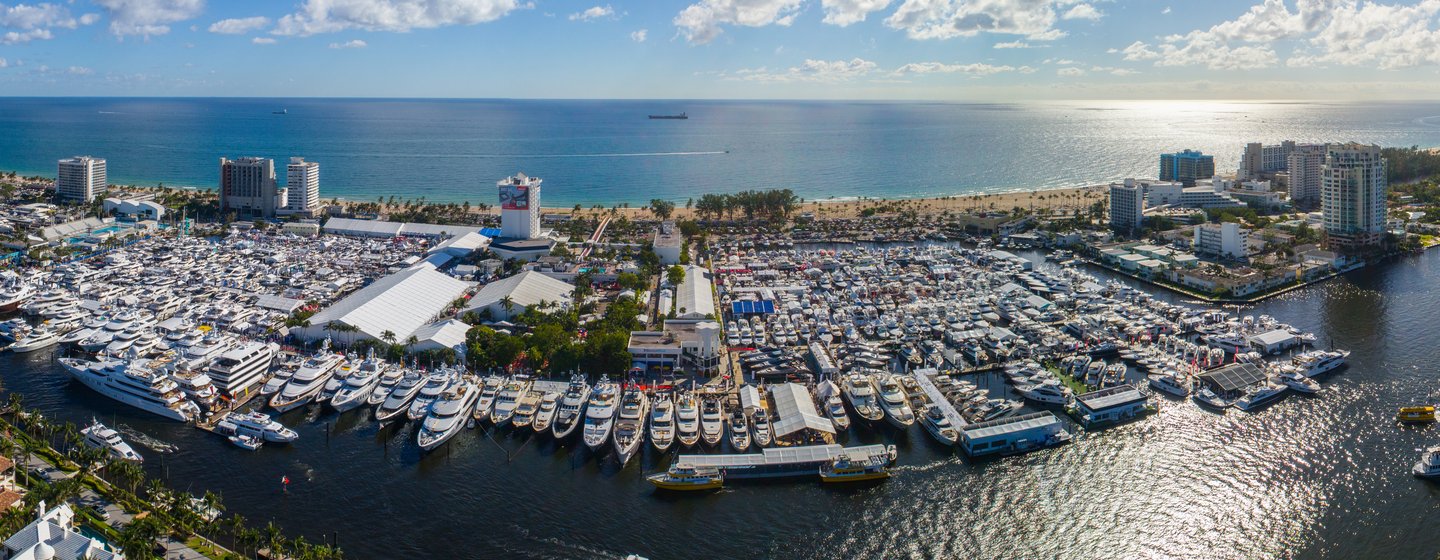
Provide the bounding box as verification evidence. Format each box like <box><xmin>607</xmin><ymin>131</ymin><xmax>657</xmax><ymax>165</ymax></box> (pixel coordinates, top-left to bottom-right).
<box><xmin>59</xmin><ymin>356</ymin><xmax>200</xmax><ymax>422</ymax></box>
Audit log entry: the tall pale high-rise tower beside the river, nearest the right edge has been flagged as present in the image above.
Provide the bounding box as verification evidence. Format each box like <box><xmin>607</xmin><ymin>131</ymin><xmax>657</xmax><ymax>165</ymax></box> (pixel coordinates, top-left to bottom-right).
<box><xmin>1320</xmin><ymin>144</ymin><xmax>1387</xmax><ymax>249</ymax></box>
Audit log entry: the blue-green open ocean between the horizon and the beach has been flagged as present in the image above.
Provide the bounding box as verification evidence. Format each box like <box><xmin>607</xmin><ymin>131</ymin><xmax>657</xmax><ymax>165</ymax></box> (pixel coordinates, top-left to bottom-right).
<box><xmin>8</xmin><ymin>98</ymin><xmax>1440</xmax><ymax>207</ymax></box>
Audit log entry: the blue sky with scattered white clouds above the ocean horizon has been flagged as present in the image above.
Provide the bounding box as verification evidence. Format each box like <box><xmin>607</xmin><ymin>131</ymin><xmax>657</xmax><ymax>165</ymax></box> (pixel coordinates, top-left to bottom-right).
<box><xmin>0</xmin><ymin>0</ymin><xmax>1440</xmax><ymax>101</ymax></box>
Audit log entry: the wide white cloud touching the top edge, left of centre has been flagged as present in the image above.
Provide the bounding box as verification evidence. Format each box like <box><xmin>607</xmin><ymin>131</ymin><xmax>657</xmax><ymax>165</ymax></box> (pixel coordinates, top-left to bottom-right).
<box><xmin>272</xmin><ymin>0</ymin><xmax>530</xmax><ymax>36</ymax></box>
